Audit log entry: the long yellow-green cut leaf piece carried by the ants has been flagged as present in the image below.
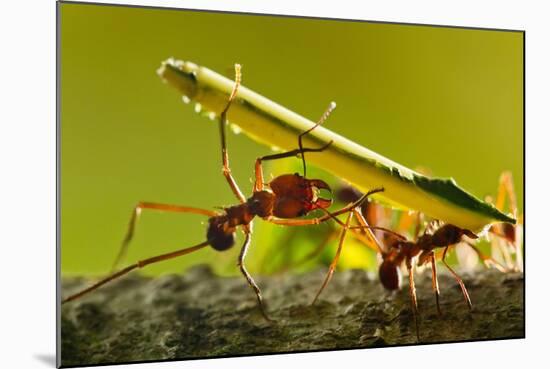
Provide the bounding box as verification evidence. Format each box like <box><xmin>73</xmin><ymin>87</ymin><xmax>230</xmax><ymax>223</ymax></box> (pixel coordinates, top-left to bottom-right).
<box><xmin>157</xmin><ymin>58</ymin><xmax>516</xmax><ymax>231</ymax></box>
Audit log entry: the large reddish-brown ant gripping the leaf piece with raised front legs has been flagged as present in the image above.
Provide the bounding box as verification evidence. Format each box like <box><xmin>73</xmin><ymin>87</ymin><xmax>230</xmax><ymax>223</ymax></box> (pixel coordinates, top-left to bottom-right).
<box><xmin>62</xmin><ymin>64</ymin><xmax>383</xmax><ymax>321</ymax></box>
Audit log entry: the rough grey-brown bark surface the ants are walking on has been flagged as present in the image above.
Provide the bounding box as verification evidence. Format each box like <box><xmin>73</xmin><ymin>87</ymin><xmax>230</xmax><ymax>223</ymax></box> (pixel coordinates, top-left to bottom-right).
<box><xmin>61</xmin><ymin>266</ymin><xmax>525</xmax><ymax>366</ymax></box>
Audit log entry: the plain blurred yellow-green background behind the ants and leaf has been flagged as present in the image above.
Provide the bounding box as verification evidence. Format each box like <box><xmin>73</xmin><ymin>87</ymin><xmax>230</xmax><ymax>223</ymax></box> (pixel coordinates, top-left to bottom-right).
<box><xmin>59</xmin><ymin>3</ymin><xmax>523</xmax><ymax>274</ymax></box>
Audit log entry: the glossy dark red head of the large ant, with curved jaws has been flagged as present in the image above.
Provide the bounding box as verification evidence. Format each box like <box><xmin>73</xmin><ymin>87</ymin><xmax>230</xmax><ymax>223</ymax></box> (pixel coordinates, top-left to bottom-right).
<box><xmin>269</xmin><ymin>173</ymin><xmax>332</xmax><ymax>218</ymax></box>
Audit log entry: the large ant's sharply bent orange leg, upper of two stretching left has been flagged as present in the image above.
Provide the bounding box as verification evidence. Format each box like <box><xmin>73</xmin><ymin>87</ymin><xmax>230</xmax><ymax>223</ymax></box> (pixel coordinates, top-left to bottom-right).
<box><xmin>110</xmin><ymin>202</ymin><xmax>218</xmax><ymax>273</ymax></box>
